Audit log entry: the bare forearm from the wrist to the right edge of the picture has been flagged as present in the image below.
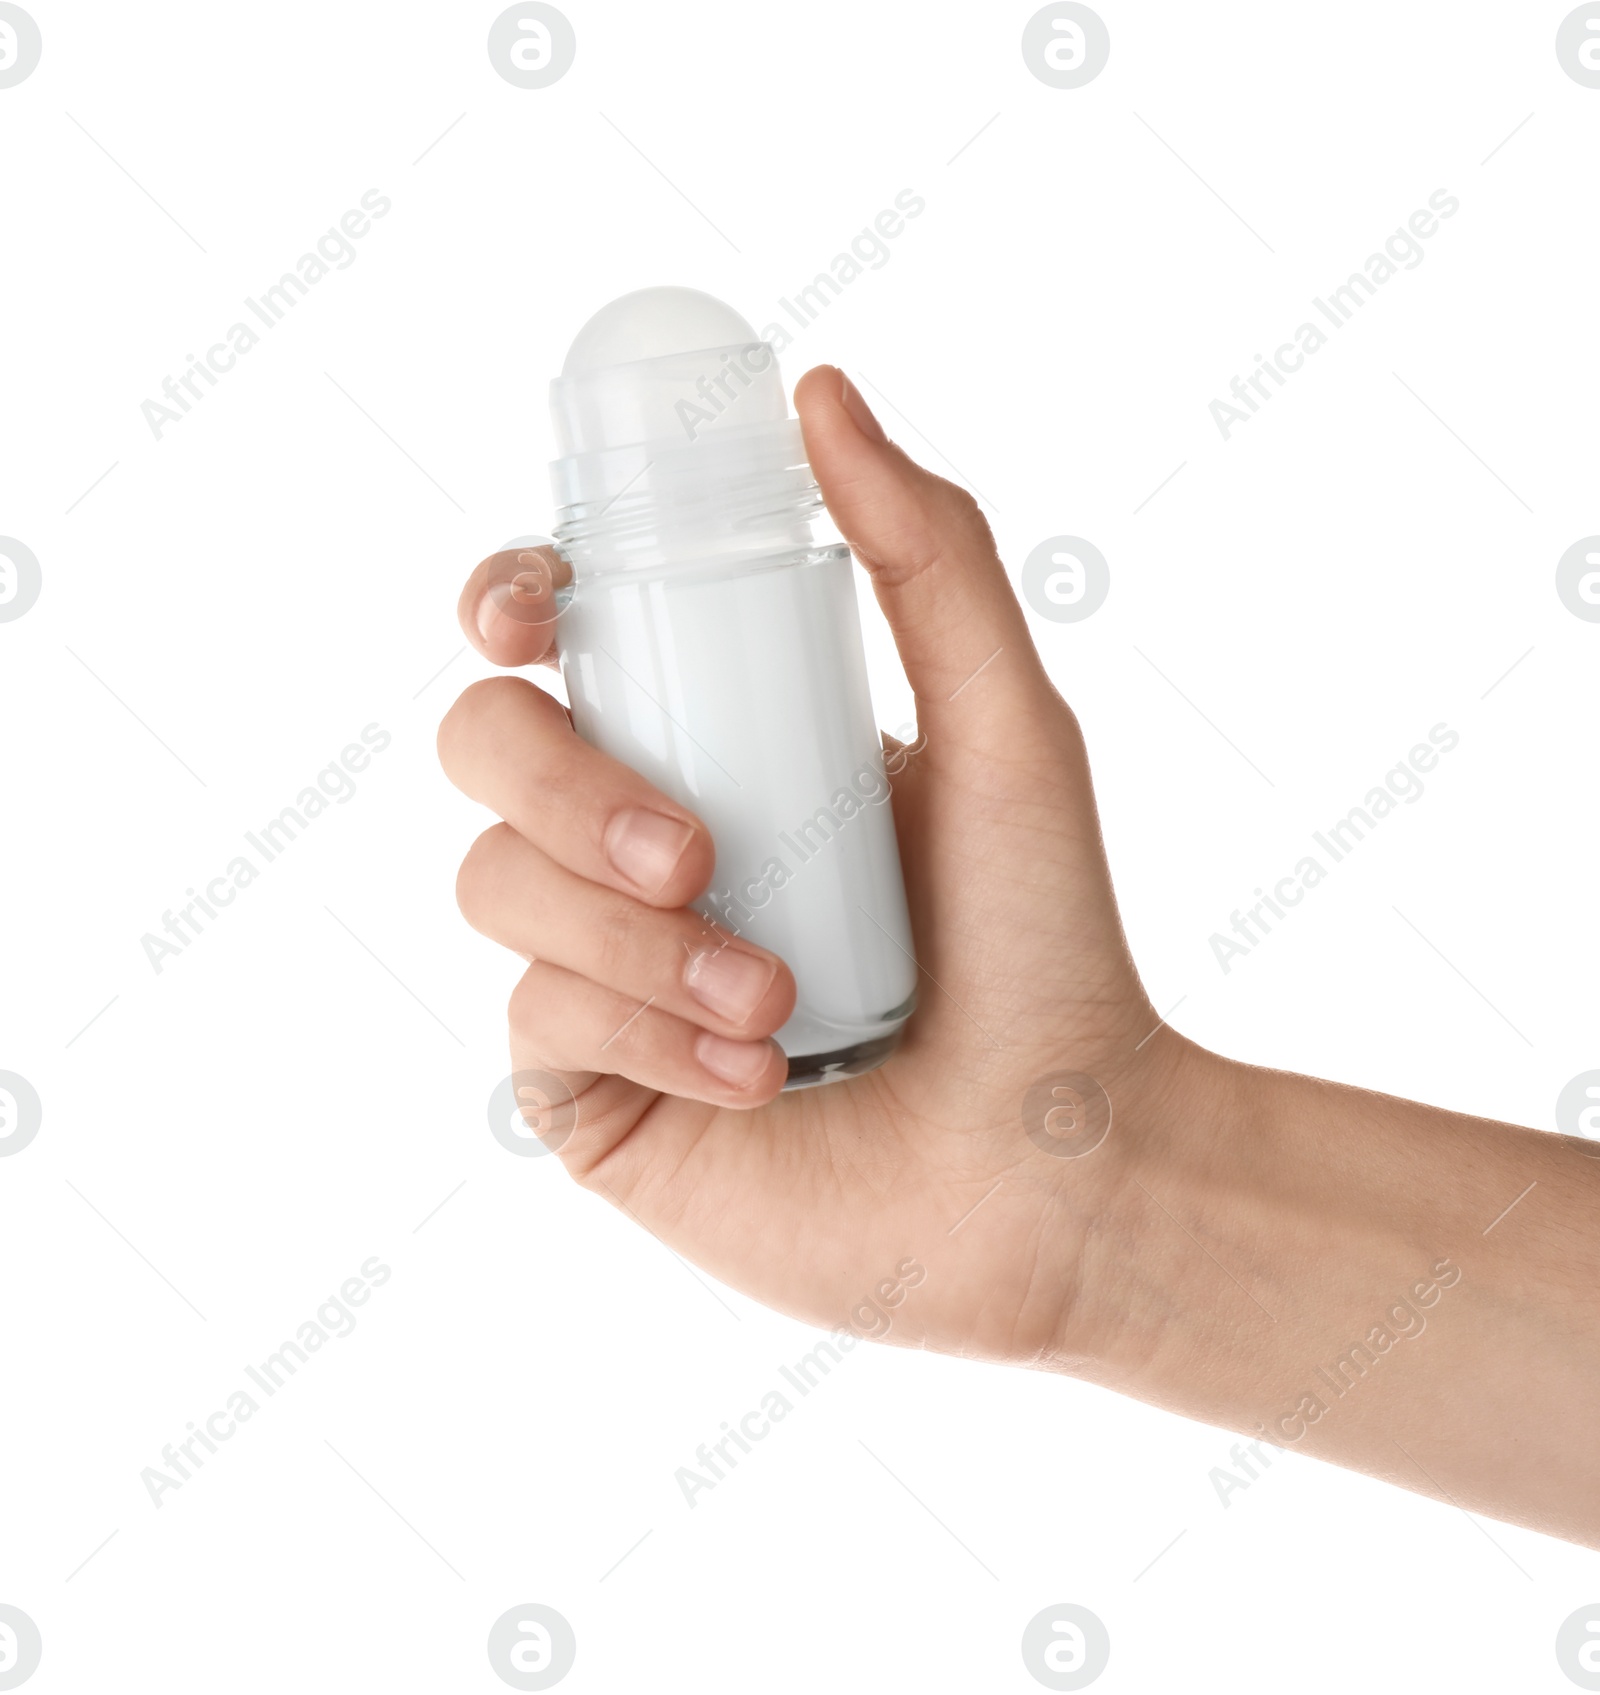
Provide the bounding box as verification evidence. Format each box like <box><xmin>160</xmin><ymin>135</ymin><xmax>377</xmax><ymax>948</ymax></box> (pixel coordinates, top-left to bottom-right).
<box><xmin>1076</xmin><ymin>1037</ymin><xmax>1600</xmax><ymax>1546</ymax></box>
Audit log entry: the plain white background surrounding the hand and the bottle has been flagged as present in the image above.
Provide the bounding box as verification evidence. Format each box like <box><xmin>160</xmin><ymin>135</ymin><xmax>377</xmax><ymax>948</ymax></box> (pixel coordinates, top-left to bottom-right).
<box><xmin>0</xmin><ymin>0</ymin><xmax>1600</xmax><ymax>1695</ymax></box>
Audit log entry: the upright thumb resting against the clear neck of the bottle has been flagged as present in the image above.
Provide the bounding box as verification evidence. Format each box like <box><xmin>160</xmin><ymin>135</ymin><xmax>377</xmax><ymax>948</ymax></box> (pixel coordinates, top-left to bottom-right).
<box><xmin>795</xmin><ymin>364</ymin><xmax>1053</xmax><ymax>732</ymax></box>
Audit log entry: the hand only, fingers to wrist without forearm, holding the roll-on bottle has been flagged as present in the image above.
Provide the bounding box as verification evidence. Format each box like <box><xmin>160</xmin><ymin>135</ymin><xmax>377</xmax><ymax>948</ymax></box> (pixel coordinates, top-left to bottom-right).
<box><xmin>439</xmin><ymin>366</ymin><xmax>1200</xmax><ymax>1364</ymax></box>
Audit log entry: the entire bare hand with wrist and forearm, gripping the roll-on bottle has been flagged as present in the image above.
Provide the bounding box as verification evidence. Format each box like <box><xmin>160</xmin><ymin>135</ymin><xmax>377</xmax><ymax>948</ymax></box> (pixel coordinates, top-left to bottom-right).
<box><xmin>439</xmin><ymin>366</ymin><xmax>1600</xmax><ymax>1546</ymax></box>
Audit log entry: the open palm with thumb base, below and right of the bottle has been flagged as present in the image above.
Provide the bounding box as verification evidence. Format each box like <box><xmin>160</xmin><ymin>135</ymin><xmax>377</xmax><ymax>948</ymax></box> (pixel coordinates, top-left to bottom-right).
<box><xmin>578</xmin><ymin>678</ymin><xmax>1154</xmax><ymax>1358</ymax></box>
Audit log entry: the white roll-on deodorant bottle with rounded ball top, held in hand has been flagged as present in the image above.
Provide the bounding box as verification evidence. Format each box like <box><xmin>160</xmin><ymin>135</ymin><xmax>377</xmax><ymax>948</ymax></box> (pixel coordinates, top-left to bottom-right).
<box><xmin>551</xmin><ymin>288</ymin><xmax>917</xmax><ymax>1088</ymax></box>
